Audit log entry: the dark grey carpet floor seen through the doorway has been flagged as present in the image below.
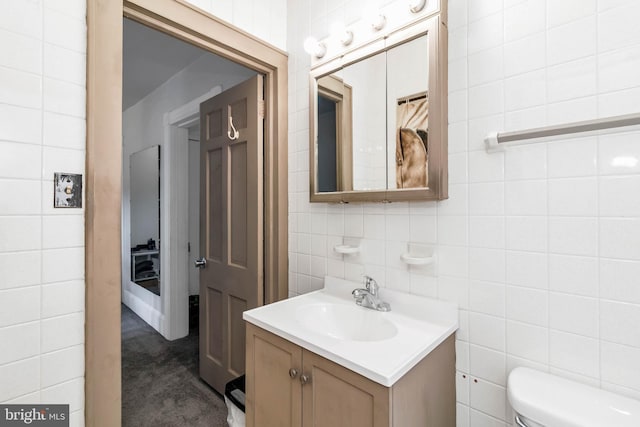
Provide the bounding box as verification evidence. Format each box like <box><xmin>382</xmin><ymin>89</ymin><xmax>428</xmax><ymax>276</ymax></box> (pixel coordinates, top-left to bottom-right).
<box><xmin>122</xmin><ymin>305</ymin><xmax>227</xmax><ymax>427</ymax></box>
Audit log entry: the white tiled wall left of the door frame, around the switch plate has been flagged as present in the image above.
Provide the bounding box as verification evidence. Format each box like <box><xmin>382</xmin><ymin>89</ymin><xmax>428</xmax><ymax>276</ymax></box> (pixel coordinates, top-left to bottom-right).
<box><xmin>0</xmin><ymin>0</ymin><xmax>86</xmax><ymax>426</ymax></box>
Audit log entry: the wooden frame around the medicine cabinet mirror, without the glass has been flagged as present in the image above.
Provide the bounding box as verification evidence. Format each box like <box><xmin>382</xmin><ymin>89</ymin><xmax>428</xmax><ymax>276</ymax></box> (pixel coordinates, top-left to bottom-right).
<box><xmin>309</xmin><ymin>12</ymin><xmax>449</xmax><ymax>203</ymax></box>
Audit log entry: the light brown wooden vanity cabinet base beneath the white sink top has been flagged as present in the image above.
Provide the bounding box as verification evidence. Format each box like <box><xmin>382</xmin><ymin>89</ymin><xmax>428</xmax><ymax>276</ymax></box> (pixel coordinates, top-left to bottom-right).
<box><xmin>246</xmin><ymin>323</ymin><xmax>456</xmax><ymax>427</ymax></box>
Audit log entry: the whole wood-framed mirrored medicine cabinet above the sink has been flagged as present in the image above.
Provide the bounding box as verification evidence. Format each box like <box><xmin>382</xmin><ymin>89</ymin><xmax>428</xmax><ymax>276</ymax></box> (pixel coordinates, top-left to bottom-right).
<box><xmin>309</xmin><ymin>14</ymin><xmax>448</xmax><ymax>203</ymax></box>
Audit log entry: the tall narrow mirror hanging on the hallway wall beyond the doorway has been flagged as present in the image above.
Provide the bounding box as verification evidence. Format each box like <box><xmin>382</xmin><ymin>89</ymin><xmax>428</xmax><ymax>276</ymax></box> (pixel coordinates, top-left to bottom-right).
<box><xmin>129</xmin><ymin>145</ymin><xmax>160</xmax><ymax>295</ymax></box>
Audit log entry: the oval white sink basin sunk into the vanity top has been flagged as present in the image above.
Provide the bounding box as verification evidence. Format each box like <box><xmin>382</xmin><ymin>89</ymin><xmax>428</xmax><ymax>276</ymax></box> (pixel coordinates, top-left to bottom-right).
<box><xmin>296</xmin><ymin>303</ymin><xmax>398</xmax><ymax>341</ymax></box>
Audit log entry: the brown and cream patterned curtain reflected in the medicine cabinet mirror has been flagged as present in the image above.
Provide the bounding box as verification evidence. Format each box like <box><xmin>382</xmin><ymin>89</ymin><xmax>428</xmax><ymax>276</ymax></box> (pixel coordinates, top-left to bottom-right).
<box><xmin>396</xmin><ymin>94</ymin><xmax>429</xmax><ymax>188</ymax></box>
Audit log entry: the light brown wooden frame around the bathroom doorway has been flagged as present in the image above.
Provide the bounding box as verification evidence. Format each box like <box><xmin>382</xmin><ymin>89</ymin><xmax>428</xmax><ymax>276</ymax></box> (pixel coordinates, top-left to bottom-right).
<box><xmin>85</xmin><ymin>0</ymin><xmax>288</xmax><ymax>426</ymax></box>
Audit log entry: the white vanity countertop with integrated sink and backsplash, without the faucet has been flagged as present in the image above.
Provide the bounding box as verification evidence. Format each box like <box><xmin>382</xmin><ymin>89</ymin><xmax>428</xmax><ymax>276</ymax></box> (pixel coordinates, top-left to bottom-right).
<box><xmin>242</xmin><ymin>277</ymin><xmax>458</xmax><ymax>387</ymax></box>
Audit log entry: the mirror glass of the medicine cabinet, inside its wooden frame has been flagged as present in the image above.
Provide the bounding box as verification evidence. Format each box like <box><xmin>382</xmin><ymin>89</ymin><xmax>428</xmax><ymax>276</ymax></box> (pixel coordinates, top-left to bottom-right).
<box><xmin>315</xmin><ymin>35</ymin><xmax>429</xmax><ymax>193</ymax></box>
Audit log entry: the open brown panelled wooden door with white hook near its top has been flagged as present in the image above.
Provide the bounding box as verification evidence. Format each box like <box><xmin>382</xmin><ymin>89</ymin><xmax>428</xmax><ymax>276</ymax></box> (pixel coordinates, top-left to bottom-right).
<box><xmin>200</xmin><ymin>75</ymin><xmax>264</xmax><ymax>394</ymax></box>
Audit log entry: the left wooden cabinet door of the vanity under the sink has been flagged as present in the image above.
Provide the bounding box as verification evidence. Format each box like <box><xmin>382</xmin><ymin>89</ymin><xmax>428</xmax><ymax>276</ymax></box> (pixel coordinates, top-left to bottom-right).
<box><xmin>246</xmin><ymin>323</ymin><xmax>302</xmax><ymax>427</ymax></box>
